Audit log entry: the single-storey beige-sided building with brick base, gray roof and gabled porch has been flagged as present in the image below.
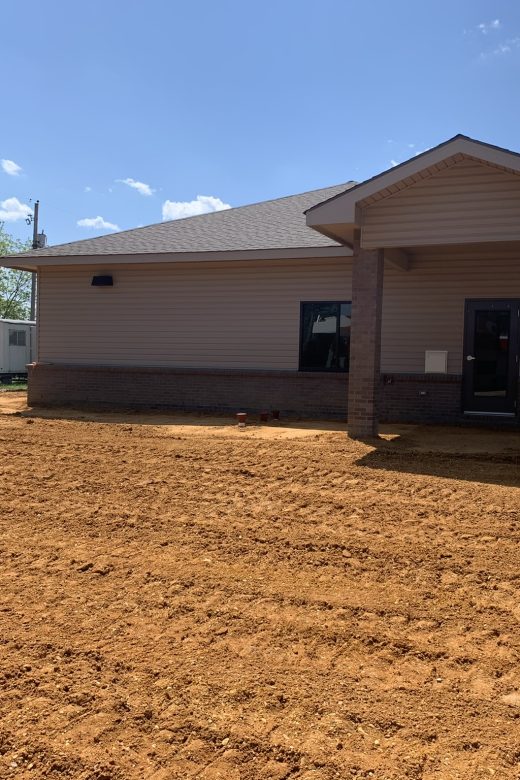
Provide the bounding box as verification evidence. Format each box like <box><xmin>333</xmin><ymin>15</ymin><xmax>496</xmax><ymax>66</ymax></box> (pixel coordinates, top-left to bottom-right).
<box><xmin>2</xmin><ymin>135</ymin><xmax>520</xmax><ymax>437</ymax></box>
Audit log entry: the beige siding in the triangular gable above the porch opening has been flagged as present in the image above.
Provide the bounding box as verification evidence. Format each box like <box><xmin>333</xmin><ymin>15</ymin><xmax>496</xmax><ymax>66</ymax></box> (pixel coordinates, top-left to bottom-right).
<box><xmin>361</xmin><ymin>158</ymin><xmax>520</xmax><ymax>248</ymax></box>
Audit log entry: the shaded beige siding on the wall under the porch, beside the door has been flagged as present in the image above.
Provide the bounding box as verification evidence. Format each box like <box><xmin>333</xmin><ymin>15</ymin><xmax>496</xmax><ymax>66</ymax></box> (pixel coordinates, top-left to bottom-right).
<box><xmin>381</xmin><ymin>250</ymin><xmax>520</xmax><ymax>374</ymax></box>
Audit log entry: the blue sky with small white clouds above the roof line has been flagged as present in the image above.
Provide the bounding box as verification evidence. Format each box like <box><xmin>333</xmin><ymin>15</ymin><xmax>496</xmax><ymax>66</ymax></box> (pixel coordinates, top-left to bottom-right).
<box><xmin>0</xmin><ymin>0</ymin><xmax>520</xmax><ymax>244</ymax></box>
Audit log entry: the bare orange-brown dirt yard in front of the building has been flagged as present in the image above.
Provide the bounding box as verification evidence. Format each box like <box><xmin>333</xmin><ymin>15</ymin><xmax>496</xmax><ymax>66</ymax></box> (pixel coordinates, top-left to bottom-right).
<box><xmin>0</xmin><ymin>393</ymin><xmax>520</xmax><ymax>780</ymax></box>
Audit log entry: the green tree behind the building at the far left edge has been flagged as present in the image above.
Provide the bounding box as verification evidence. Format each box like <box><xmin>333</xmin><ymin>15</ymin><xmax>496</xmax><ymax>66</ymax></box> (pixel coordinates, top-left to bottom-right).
<box><xmin>0</xmin><ymin>222</ymin><xmax>31</xmax><ymax>320</ymax></box>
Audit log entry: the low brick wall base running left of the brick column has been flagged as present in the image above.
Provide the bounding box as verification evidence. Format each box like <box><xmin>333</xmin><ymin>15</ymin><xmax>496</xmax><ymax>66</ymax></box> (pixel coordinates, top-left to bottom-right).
<box><xmin>28</xmin><ymin>363</ymin><xmax>348</xmax><ymax>419</ymax></box>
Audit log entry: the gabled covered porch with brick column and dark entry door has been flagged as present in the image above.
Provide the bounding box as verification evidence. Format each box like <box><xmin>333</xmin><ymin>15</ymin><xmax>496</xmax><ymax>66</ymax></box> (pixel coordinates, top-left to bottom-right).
<box><xmin>307</xmin><ymin>136</ymin><xmax>520</xmax><ymax>438</ymax></box>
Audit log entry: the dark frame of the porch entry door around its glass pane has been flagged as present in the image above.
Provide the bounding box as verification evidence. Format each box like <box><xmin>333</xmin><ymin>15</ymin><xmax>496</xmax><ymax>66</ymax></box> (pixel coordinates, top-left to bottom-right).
<box><xmin>461</xmin><ymin>298</ymin><xmax>520</xmax><ymax>417</ymax></box>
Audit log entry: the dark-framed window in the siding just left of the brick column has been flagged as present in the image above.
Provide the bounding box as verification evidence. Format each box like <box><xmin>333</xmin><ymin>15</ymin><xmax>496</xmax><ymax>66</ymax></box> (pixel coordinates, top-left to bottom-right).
<box><xmin>300</xmin><ymin>301</ymin><xmax>352</xmax><ymax>371</ymax></box>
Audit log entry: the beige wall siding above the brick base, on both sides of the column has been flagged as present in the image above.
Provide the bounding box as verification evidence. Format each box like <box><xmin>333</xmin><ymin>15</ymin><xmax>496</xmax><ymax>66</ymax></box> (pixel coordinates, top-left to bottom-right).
<box><xmin>39</xmin><ymin>248</ymin><xmax>520</xmax><ymax>374</ymax></box>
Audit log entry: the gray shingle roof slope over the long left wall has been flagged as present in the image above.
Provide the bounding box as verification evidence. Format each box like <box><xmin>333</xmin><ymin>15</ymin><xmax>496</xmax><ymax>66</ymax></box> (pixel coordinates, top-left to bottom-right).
<box><xmin>10</xmin><ymin>182</ymin><xmax>355</xmax><ymax>257</ymax></box>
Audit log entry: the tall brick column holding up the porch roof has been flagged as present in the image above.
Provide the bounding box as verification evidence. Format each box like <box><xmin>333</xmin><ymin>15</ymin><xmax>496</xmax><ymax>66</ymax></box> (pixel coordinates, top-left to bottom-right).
<box><xmin>348</xmin><ymin>243</ymin><xmax>384</xmax><ymax>439</ymax></box>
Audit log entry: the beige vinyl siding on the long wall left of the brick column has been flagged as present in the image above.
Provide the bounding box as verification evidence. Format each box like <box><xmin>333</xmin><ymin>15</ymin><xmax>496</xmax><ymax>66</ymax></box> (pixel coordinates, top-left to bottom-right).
<box><xmin>39</xmin><ymin>258</ymin><xmax>352</xmax><ymax>370</ymax></box>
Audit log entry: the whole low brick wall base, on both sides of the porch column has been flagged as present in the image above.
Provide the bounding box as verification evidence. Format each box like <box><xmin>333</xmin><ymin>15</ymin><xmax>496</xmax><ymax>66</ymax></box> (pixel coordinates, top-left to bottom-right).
<box><xmin>29</xmin><ymin>363</ymin><xmax>520</xmax><ymax>425</ymax></box>
